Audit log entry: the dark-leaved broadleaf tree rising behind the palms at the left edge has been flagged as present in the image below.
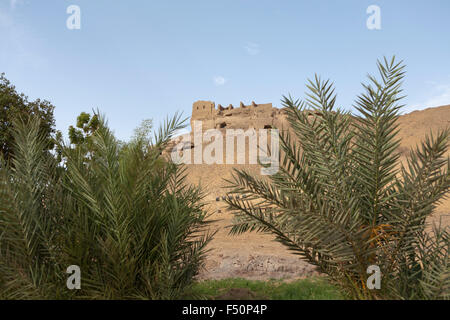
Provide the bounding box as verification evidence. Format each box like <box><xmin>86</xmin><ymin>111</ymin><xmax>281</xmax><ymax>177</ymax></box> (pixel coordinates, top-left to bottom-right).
<box><xmin>0</xmin><ymin>73</ymin><xmax>55</xmax><ymax>160</ymax></box>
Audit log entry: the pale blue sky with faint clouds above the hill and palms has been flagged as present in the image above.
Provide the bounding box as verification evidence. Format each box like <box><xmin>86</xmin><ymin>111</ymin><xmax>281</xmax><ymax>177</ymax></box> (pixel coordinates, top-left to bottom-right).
<box><xmin>0</xmin><ymin>0</ymin><xmax>450</xmax><ymax>139</ymax></box>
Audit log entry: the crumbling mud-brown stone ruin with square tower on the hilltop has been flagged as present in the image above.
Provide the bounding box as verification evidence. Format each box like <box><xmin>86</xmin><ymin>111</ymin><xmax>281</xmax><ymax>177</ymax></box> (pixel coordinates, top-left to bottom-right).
<box><xmin>191</xmin><ymin>100</ymin><xmax>284</xmax><ymax>130</ymax></box>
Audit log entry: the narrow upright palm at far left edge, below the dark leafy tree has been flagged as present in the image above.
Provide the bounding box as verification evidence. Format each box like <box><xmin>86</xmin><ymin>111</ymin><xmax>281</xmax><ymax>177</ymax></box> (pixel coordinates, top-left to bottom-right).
<box><xmin>0</xmin><ymin>118</ymin><xmax>64</xmax><ymax>299</ymax></box>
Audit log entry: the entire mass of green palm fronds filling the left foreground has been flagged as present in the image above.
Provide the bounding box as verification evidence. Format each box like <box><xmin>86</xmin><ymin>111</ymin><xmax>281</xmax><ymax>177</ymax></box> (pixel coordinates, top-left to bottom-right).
<box><xmin>0</xmin><ymin>116</ymin><xmax>212</xmax><ymax>299</ymax></box>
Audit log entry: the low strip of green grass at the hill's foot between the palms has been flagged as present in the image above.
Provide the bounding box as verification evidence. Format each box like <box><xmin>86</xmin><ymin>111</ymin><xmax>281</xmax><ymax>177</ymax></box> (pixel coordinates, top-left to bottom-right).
<box><xmin>188</xmin><ymin>278</ymin><xmax>344</xmax><ymax>300</ymax></box>
